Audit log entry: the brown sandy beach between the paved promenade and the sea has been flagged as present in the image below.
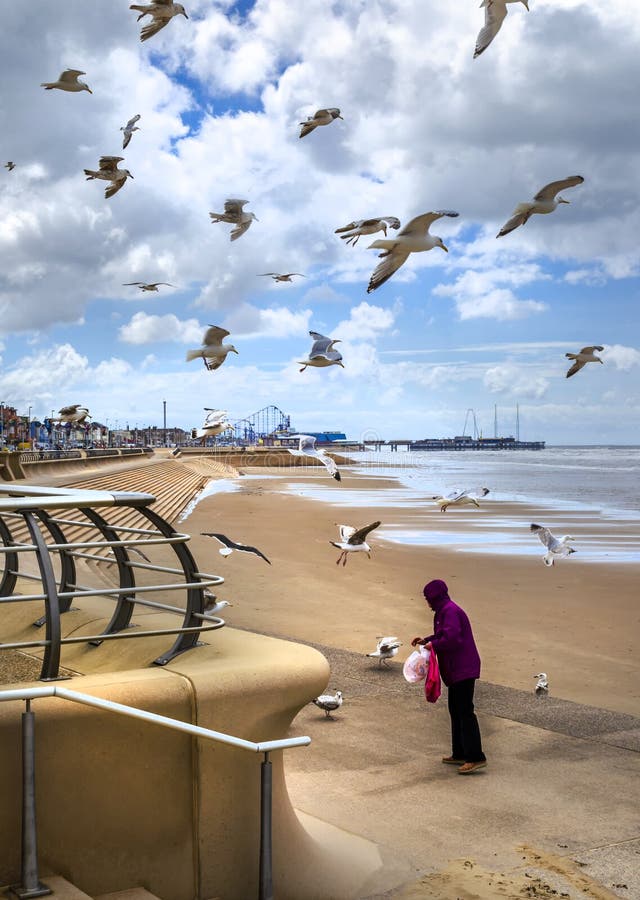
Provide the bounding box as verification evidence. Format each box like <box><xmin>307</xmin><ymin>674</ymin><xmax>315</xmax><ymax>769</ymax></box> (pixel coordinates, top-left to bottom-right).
<box><xmin>181</xmin><ymin>468</ymin><xmax>640</xmax><ymax>715</ymax></box>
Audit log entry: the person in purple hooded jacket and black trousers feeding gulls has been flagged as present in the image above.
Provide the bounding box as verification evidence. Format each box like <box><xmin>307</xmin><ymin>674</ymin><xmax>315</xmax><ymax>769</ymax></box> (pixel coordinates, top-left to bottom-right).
<box><xmin>411</xmin><ymin>579</ymin><xmax>487</xmax><ymax>775</ymax></box>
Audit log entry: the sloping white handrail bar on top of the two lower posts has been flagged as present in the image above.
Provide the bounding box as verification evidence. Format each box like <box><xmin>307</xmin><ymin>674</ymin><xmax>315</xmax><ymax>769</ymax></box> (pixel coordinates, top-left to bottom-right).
<box><xmin>0</xmin><ymin>684</ymin><xmax>311</xmax><ymax>753</ymax></box>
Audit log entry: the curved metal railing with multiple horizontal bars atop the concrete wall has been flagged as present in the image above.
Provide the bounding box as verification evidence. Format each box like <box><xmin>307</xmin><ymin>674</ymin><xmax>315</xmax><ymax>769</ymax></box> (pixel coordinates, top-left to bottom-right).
<box><xmin>0</xmin><ymin>485</ymin><xmax>224</xmax><ymax>681</ymax></box>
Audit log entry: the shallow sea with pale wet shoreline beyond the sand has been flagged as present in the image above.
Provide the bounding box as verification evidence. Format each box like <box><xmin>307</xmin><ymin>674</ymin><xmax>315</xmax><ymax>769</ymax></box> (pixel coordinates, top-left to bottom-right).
<box><xmin>182</xmin><ymin>445</ymin><xmax>640</xmax><ymax>565</ymax></box>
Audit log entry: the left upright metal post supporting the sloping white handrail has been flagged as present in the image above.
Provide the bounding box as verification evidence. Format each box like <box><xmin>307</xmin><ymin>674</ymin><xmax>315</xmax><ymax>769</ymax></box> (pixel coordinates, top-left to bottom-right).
<box><xmin>9</xmin><ymin>700</ymin><xmax>53</xmax><ymax>900</ymax></box>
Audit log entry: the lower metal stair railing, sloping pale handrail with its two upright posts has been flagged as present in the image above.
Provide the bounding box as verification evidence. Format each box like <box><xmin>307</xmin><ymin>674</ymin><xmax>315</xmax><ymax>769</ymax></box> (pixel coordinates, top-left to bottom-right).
<box><xmin>0</xmin><ymin>685</ymin><xmax>311</xmax><ymax>900</ymax></box>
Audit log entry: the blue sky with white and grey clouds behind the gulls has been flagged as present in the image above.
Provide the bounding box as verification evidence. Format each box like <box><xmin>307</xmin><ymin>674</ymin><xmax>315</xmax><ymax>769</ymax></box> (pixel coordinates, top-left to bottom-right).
<box><xmin>0</xmin><ymin>0</ymin><xmax>640</xmax><ymax>444</ymax></box>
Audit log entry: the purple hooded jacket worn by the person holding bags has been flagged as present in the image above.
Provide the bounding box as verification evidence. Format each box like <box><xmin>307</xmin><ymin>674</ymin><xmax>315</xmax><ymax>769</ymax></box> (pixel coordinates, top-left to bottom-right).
<box><xmin>424</xmin><ymin>580</ymin><xmax>480</xmax><ymax>686</ymax></box>
